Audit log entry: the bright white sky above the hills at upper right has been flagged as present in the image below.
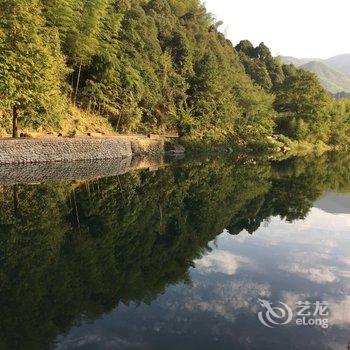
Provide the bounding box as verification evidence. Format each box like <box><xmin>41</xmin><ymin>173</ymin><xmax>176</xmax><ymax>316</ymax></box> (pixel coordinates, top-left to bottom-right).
<box><xmin>203</xmin><ymin>0</ymin><xmax>350</xmax><ymax>58</ymax></box>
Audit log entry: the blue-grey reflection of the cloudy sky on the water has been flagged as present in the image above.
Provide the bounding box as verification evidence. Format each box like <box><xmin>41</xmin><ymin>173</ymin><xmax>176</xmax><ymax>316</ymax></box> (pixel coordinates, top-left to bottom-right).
<box><xmin>54</xmin><ymin>195</ymin><xmax>350</xmax><ymax>350</ymax></box>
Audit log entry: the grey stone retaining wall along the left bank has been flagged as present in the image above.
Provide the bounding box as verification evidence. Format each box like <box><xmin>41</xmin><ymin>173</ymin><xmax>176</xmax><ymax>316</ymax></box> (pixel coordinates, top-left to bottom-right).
<box><xmin>0</xmin><ymin>136</ymin><xmax>164</xmax><ymax>164</ymax></box>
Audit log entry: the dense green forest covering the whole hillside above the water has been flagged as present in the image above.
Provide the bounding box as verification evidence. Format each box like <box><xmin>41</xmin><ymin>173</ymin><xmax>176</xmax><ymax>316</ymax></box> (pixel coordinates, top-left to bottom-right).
<box><xmin>0</xmin><ymin>0</ymin><xmax>350</xmax><ymax>144</ymax></box>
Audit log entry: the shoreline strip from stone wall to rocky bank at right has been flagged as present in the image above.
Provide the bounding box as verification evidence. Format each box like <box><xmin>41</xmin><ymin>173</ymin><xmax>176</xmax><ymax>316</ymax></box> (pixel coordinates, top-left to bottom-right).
<box><xmin>0</xmin><ymin>134</ymin><xmax>341</xmax><ymax>166</ymax></box>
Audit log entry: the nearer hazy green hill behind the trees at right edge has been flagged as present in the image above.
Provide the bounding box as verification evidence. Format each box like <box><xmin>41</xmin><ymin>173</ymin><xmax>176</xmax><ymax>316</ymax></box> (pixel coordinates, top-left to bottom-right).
<box><xmin>299</xmin><ymin>61</ymin><xmax>350</xmax><ymax>94</ymax></box>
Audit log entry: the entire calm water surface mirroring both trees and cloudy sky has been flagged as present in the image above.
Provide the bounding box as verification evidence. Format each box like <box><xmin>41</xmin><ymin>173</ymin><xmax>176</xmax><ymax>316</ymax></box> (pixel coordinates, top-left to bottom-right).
<box><xmin>0</xmin><ymin>154</ymin><xmax>350</xmax><ymax>349</ymax></box>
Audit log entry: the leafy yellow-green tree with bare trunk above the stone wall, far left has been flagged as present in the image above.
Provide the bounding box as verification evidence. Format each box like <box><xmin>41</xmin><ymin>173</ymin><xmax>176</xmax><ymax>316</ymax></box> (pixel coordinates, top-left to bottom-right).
<box><xmin>0</xmin><ymin>0</ymin><xmax>66</xmax><ymax>137</ymax></box>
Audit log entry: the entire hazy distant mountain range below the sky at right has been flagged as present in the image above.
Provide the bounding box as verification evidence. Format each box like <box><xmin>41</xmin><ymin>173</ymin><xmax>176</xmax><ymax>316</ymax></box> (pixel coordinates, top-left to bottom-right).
<box><xmin>279</xmin><ymin>54</ymin><xmax>350</xmax><ymax>94</ymax></box>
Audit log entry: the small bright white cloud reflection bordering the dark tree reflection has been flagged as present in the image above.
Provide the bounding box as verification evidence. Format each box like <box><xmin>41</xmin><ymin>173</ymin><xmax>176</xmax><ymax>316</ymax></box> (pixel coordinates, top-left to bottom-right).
<box><xmin>194</xmin><ymin>249</ymin><xmax>250</xmax><ymax>275</ymax></box>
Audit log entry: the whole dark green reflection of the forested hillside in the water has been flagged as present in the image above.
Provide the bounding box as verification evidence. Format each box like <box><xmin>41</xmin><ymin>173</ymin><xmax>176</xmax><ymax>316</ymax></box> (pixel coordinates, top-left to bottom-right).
<box><xmin>0</xmin><ymin>155</ymin><xmax>350</xmax><ymax>349</ymax></box>
